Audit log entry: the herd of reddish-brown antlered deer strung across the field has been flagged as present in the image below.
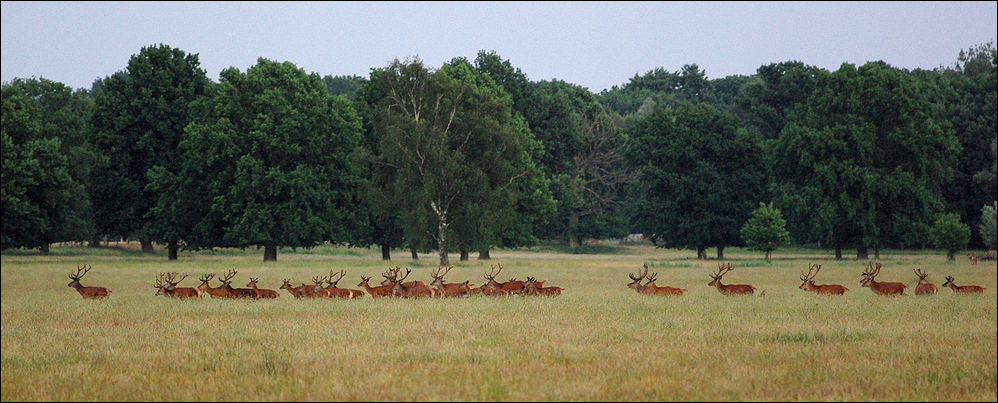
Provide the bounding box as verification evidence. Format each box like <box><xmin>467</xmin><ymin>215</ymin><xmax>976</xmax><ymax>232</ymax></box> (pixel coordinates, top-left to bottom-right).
<box><xmin>68</xmin><ymin>262</ymin><xmax>984</xmax><ymax>299</ymax></box>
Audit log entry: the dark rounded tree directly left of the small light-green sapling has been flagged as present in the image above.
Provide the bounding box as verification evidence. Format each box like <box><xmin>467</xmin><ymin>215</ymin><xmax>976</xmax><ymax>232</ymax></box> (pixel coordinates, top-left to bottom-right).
<box><xmin>626</xmin><ymin>102</ymin><xmax>765</xmax><ymax>259</ymax></box>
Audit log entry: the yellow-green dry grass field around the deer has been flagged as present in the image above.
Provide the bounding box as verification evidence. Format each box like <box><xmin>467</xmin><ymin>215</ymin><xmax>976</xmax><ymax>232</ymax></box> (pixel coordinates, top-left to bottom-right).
<box><xmin>0</xmin><ymin>244</ymin><xmax>998</xmax><ymax>402</ymax></box>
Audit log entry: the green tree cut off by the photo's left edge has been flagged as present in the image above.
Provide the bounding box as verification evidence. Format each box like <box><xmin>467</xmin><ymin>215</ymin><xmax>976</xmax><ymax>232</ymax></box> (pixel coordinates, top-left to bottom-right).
<box><xmin>0</xmin><ymin>78</ymin><xmax>93</xmax><ymax>255</ymax></box>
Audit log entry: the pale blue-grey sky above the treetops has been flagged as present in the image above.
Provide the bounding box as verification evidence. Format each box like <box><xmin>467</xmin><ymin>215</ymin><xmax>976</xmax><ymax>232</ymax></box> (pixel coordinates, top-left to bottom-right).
<box><xmin>0</xmin><ymin>0</ymin><xmax>998</xmax><ymax>93</ymax></box>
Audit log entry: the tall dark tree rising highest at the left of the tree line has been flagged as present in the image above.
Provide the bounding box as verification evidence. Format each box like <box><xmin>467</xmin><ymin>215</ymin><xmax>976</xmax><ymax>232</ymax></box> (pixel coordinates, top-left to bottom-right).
<box><xmin>93</xmin><ymin>44</ymin><xmax>209</xmax><ymax>260</ymax></box>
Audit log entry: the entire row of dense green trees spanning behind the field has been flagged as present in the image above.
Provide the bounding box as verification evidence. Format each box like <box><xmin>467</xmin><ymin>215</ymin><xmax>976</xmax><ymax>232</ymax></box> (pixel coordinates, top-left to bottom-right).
<box><xmin>0</xmin><ymin>42</ymin><xmax>998</xmax><ymax>266</ymax></box>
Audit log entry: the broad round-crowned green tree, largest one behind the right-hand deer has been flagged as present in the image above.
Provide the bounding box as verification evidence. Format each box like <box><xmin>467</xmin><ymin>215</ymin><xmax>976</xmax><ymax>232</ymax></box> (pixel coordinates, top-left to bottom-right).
<box><xmin>766</xmin><ymin>62</ymin><xmax>960</xmax><ymax>259</ymax></box>
